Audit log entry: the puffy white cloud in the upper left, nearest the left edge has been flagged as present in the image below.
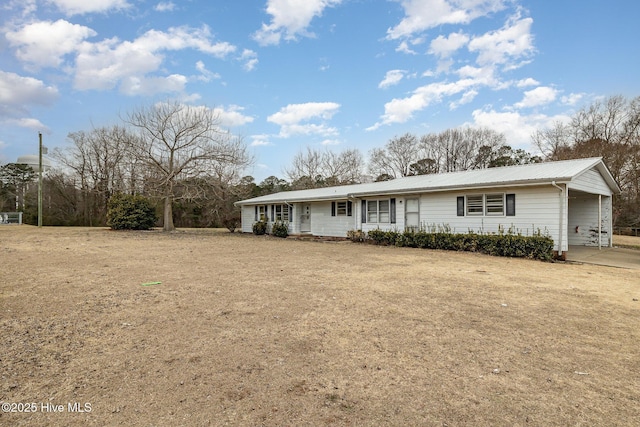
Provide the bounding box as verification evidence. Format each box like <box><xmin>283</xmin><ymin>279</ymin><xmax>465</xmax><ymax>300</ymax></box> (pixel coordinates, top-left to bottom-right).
<box><xmin>5</xmin><ymin>19</ymin><xmax>97</xmax><ymax>67</ymax></box>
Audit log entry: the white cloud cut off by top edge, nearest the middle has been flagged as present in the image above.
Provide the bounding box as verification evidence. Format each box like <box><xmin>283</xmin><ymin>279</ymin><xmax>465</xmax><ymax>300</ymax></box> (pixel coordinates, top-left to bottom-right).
<box><xmin>253</xmin><ymin>0</ymin><xmax>342</xmax><ymax>46</ymax></box>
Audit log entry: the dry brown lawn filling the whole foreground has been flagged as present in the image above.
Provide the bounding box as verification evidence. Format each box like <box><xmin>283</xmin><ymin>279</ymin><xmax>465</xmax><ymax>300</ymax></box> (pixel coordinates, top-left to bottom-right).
<box><xmin>0</xmin><ymin>226</ymin><xmax>640</xmax><ymax>426</ymax></box>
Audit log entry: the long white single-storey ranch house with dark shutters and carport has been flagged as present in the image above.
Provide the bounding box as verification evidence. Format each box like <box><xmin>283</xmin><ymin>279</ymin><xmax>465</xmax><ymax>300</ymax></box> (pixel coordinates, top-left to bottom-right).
<box><xmin>236</xmin><ymin>157</ymin><xmax>620</xmax><ymax>256</ymax></box>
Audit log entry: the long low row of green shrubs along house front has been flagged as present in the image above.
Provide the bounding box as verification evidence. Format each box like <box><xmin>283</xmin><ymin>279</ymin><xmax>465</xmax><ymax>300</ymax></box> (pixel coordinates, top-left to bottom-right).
<box><xmin>347</xmin><ymin>229</ymin><xmax>553</xmax><ymax>261</ymax></box>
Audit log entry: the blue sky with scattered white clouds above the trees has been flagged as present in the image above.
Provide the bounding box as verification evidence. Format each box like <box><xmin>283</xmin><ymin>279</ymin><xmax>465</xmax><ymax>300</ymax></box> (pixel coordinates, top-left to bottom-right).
<box><xmin>0</xmin><ymin>0</ymin><xmax>640</xmax><ymax>182</ymax></box>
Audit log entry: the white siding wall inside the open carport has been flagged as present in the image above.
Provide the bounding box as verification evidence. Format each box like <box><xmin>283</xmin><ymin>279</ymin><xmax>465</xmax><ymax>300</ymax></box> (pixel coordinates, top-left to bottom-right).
<box><xmin>568</xmin><ymin>193</ymin><xmax>611</xmax><ymax>246</ymax></box>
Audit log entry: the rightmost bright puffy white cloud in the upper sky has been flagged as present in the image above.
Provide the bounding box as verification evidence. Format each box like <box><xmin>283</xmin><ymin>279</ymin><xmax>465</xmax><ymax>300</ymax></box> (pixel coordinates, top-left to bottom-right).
<box><xmin>469</xmin><ymin>16</ymin><xmax>534</xmax><ymax>68</ymax></box>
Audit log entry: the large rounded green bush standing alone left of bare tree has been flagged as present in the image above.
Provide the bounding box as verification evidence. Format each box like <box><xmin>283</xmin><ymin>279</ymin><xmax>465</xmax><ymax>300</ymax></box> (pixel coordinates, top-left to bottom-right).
<box><xmin>107</xmin><ymin>193</ymin><xmax>158</xmax><ymax>230</ymax></box>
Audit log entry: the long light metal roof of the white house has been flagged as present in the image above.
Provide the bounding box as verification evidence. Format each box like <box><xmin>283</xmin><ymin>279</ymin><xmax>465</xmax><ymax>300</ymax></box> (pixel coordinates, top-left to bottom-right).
<box><xmin>236</xmin><ymin>157</ymin><xmax>620</xmax><ymax>205</ymax></box>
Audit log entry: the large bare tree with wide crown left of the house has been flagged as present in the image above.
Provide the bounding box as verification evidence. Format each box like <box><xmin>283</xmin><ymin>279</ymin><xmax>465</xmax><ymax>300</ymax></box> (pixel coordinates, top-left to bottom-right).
<box><xmin>125</xmin><ymin>101</ymin><xmax>252</xmax><ymax>231</ymax></box>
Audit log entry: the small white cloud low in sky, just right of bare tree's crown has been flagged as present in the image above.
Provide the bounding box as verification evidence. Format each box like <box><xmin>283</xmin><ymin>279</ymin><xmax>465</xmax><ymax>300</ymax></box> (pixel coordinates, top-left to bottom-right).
<box><xmin>267</xmin><ymin>102</ymin><xmax>340</xmax><ymax>138</ymax></box>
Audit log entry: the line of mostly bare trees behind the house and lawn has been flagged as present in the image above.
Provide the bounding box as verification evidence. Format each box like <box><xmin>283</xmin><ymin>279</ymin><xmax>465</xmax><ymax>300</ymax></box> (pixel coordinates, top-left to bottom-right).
<box><xmin>0</xmin><ymin>96</ymin><xmax>640</xmax><ymax>230</ymax></box>
